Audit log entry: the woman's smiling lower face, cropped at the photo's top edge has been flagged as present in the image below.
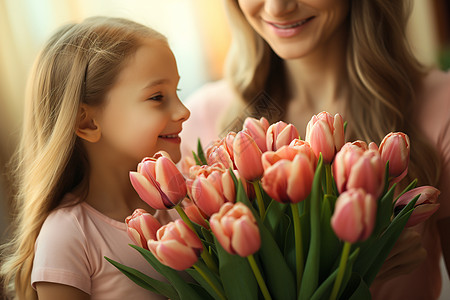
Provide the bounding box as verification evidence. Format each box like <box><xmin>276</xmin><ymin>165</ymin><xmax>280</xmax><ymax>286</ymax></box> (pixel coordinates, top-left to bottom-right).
<box><xmin>237</xmin><ymin>0</ymin><xmax>349</xmax><ymax>59</ymax></box>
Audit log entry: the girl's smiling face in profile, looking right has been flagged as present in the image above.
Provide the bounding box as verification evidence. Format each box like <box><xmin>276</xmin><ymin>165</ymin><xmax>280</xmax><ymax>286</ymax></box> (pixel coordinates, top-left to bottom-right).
<box><xmin>97</xmin><ymin>40</ymin><xmax>190</xmax><ymax>167</ymax></box>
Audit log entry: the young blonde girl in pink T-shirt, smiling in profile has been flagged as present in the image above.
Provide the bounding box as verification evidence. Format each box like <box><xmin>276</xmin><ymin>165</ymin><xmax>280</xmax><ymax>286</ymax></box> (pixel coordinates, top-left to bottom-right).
<box><xmin>2</xmin><ymin>17</ymin><xmax>189</xmax><ymax>300</ymax></box>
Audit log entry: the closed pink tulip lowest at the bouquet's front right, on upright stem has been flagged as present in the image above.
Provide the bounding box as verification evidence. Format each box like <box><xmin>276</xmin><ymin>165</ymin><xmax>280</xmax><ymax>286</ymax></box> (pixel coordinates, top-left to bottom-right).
<box><xmin>331</xmin><ymin>189</ymin><xmax>377</xmax><ymax>243</ymax></box>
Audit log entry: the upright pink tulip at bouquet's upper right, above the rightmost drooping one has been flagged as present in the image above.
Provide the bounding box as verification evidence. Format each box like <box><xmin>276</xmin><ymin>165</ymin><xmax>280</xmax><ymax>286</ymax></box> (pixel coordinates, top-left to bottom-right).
<box><xmin>379</xmin><ymin>132</ymin><xmax>410</xmax><ymax>182</ymax></box>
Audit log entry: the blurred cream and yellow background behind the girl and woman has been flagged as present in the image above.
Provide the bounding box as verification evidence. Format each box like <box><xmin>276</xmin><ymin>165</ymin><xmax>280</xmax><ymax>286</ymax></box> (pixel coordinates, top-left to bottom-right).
<box><xmin>0</xmin><ymin>0</ymin><xmax>450</xmax><ymax>299</ymax></box>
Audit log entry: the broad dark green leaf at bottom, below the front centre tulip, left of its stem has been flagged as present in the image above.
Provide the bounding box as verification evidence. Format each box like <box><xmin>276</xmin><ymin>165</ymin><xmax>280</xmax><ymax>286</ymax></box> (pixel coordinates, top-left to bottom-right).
<box><xmin>215</xmin><ymin>239</ymin><xmax>259</xmax><ymax>300</ymax></box>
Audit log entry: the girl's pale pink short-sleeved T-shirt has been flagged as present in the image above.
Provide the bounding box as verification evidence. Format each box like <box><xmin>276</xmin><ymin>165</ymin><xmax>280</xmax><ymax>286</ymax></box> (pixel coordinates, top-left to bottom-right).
<box><xmin>31</xmin><ymin>194</ymin><xmax>176</xmax><ymax>300</ymax></box>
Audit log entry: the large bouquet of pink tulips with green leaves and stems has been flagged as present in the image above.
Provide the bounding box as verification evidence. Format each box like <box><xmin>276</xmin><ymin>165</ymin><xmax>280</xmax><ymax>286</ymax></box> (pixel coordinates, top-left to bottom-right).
<box><xmin>107</xmin><ymin>112</ymin><xmax>439</xmax><ymax>300</ymax></box>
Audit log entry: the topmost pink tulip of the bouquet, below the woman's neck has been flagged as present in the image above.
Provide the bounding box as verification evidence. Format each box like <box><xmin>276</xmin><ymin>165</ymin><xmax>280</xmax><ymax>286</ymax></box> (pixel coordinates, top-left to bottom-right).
<box><xmin>305</xmin><ymin>112</ymin><xmax>344</xmax><ymax>163</ymax></box>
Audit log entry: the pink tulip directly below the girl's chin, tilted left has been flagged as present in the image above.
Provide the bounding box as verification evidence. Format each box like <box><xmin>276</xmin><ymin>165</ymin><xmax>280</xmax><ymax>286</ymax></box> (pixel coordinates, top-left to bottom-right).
<box><xmin>130</xmin><ymin>152</ymin><xmax>187</xmax><ymax>209</ymax></box>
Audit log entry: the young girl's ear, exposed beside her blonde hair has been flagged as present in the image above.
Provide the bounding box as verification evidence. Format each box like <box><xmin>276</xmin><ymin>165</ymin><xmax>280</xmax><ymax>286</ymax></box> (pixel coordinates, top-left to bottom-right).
<box><xmin>76</xmin><ymin>103</ymin><xmax>102</xmax><ymax>143</ymax></box>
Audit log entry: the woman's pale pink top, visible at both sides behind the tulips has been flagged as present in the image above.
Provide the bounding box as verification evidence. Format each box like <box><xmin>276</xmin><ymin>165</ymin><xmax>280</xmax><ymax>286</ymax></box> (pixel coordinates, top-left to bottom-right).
<box><xmin>181</xmin><ymin>71</ymin><xmax>450</xmax><ymax>300</ymax></box>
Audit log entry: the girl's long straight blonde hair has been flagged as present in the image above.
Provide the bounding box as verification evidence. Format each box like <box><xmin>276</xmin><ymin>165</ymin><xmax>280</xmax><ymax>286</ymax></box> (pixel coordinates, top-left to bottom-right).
<box><xmin>1</xmin><ymin>17</ymin><xmax>166</xmax><ymax>299</ymax></box>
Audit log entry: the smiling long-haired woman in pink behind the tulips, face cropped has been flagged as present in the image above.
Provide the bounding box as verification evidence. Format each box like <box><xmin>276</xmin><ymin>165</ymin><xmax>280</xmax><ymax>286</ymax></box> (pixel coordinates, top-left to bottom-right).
<box><xmin>182</xmin><ymin>0</ymin><xmax>450</xmax><ymax>299</ymax></box>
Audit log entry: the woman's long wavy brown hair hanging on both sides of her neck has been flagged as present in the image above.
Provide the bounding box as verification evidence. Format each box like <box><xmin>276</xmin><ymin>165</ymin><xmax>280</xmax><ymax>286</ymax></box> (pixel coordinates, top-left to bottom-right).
<box><xmin>225</xmin><ymin>0</ymin><xmax>440</xmax><ymax>184</ymax></box>
